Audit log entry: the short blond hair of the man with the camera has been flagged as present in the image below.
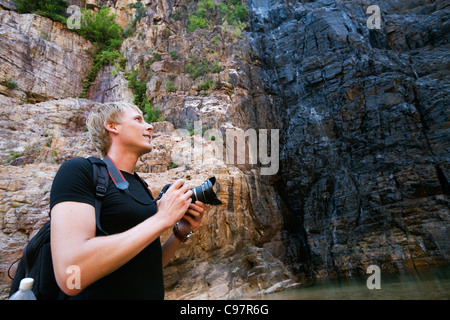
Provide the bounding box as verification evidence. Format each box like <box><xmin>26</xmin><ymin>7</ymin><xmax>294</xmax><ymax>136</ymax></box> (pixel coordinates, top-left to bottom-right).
<box><xmin>86</xmin><ymin>101</ymin><xmax>142</xmax><ymax>157</ymax></box>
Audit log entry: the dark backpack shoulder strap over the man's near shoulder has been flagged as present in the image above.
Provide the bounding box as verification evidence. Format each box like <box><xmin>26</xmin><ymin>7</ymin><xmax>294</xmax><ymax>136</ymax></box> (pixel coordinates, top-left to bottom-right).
<box><xmin>88</xmin><ymin>157</ymin><xmax>109</xmax><ymax>235</ymax></box>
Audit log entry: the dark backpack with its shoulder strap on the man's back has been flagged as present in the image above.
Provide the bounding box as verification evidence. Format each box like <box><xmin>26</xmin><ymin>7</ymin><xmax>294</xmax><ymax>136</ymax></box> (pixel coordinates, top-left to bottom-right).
<box><xmin>8</xmin><ymin>157</ymin><xmax>110</xmax><ymax>300</ymax></box>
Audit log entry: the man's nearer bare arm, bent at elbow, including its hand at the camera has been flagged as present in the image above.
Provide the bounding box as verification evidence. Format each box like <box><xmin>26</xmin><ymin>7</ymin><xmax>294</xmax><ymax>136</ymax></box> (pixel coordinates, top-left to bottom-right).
<box><xmin>51</xmin><ymin>180</ymin><xmax>192</xmax><ymax>295</ymax></box>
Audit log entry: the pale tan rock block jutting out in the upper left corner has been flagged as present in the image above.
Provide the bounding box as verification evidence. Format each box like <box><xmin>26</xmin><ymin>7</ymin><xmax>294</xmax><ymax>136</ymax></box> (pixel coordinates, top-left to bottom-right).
<box><xmin>0</xmin><ymin>10</ymin><xmax>94</xmax><ymax>103</ymax></box>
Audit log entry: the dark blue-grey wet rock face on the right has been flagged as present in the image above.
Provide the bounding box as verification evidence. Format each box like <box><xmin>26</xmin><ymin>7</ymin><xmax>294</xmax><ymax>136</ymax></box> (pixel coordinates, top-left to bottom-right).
<box><xmin>248</xmin><ymin>0</ymin><xmax>450</xmax><ymax>277</ymax></box>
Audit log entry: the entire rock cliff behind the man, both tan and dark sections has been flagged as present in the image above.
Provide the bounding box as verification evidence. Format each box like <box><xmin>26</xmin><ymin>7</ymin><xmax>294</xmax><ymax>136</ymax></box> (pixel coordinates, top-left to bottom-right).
<box><xmin>0</xmin><ymin>0</ymin><xmax>450</xmax><ymax>299</ymax></box>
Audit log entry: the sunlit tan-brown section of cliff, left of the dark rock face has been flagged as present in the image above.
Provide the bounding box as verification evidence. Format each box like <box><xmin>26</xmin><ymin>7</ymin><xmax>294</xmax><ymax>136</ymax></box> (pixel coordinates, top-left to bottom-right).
<box><xmin>0</xmin><ymin>1</ymin><xmax>296</xmax><ymax>299</ymax></box>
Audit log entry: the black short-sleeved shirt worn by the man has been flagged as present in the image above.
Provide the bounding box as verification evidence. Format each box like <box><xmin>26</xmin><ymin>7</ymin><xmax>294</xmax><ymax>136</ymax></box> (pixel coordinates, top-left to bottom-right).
<box><xmin>50</xmin><ymin>158</ymin><xmax>164</xmax><ymax>299</ymax></box>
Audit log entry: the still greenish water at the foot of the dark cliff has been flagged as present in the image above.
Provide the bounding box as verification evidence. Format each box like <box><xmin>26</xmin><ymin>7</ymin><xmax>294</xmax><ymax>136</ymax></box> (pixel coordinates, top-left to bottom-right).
<box><xmin>259</xmin><ymin>268</ymin><xmax>450</xmax><ymax>300</ymax></box>
